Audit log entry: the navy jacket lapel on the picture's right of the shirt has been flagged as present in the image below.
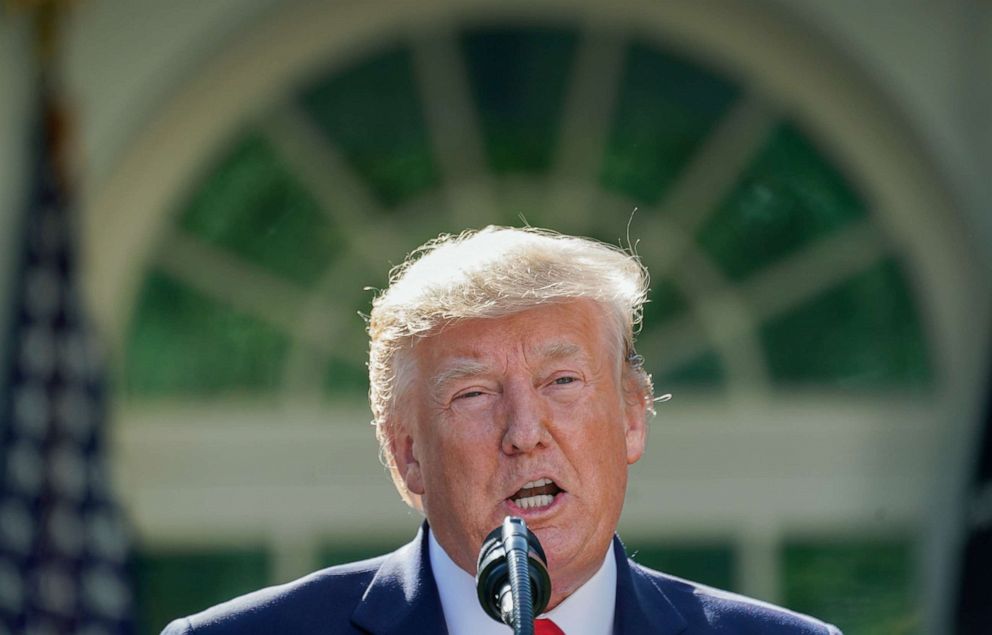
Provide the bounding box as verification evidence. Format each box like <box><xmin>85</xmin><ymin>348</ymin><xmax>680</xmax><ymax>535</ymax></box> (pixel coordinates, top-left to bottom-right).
<box><xmin>613</xmin><ymin>536</ymin><xmax>687</xmax><ymax>635</ymax></box>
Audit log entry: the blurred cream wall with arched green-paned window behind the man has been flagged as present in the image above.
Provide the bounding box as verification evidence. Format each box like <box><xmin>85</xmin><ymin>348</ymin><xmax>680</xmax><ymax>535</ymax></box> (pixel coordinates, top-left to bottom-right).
<box><xmin>0</xmin><ymin>0</ymin><xmax>992</xmax><ymax>635</ymax></box>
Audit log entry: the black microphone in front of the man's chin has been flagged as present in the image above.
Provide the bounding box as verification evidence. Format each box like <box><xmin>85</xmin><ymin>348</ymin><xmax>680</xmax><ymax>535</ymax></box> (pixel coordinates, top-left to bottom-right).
<box><xmin>475</xmin><ymin>516</ymin><xmax>551</xmax><ymax>635</ymax></box>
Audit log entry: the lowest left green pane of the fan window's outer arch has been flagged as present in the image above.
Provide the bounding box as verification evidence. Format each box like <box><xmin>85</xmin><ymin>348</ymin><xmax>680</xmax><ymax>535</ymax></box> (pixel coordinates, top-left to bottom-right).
<box><xmin>123</xmin><ymin>272</ymin><xmax>289</xmax><ymax>397</ymax></box>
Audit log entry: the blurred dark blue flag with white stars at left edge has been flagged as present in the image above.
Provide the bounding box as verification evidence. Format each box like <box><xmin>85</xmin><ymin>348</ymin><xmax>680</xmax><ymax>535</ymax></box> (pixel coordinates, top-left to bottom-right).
<box><xmin>0</xmin><ymin>79</ymin><xmax>134</xmax><ymax>635</ymax></box>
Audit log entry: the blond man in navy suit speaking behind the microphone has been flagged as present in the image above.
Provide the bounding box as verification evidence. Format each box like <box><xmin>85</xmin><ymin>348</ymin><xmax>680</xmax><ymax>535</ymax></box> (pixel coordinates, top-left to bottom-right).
<box><xmin>165</xmin><ymin>227</ymin><xmax>839</xmax><ymax>635</ymax></box>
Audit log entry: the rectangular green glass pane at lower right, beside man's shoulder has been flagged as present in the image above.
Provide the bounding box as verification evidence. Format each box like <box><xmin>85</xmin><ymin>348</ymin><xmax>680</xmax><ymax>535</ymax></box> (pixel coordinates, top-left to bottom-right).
<box><xmin>783</xmin><ymin>540</ymin><xmax>920</xmax><ymax>635</ymax></box>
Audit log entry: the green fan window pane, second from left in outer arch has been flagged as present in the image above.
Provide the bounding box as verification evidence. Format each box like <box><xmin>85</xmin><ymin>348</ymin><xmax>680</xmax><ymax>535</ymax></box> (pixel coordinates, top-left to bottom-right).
<box><xmin>179</xmin><ymin>133</ymin><xmax>343</xmax><ymax>285</ymax></box>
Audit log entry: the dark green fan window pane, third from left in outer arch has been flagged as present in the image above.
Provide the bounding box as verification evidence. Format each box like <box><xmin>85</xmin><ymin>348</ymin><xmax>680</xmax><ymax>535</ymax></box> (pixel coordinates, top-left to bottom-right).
<box><xmin>301</xmin><ymin>49</ymin><xmax>439</xmax><ymax>207</ymax></box>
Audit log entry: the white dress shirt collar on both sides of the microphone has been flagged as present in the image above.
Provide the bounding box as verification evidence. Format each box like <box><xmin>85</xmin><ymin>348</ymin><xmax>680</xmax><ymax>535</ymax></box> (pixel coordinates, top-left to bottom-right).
<box><xmin>428</xmin><ymin>532</ymin><xmax>617</xmax><ymax>635</ymax></box>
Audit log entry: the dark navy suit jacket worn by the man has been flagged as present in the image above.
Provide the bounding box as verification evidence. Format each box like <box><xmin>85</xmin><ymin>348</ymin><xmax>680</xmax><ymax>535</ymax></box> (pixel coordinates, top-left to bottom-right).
<box><xmin>163</xmin><ymin>525</ymin><xmax>840</xmax><ymax>635</ymax></box>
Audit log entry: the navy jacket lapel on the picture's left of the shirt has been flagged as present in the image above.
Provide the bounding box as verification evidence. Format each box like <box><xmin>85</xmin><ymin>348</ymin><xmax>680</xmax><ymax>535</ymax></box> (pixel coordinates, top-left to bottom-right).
<box><xmin>351</xmin><ymin>523</ymin><xmax>448</xmax><ymax>635</ymax></box>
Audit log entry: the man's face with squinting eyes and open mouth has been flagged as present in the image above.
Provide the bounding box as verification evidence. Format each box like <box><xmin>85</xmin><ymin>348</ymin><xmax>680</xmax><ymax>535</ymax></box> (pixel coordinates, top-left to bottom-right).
<box><xmin>393</xmin><ymin>300</ymin><xmax>646</xmax><ymax>606</ymax></box>
